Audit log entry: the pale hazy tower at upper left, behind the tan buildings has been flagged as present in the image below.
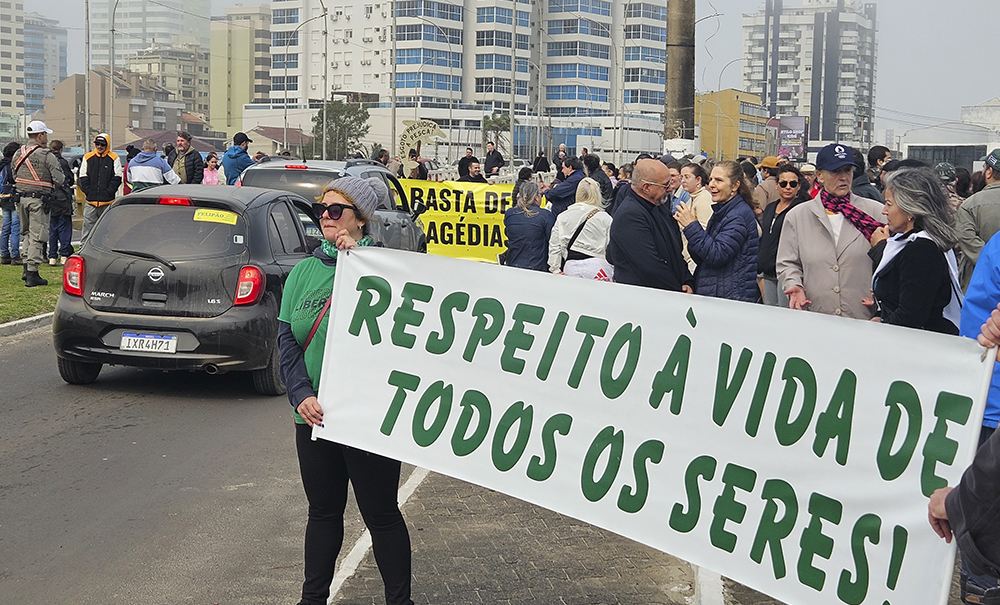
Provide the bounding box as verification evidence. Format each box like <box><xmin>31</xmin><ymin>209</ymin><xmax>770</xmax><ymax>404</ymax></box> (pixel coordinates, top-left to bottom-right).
<box><xmin>90</xmin><ymin>0</ymin><xmax>211</xmax><ymax>66</ymax></box>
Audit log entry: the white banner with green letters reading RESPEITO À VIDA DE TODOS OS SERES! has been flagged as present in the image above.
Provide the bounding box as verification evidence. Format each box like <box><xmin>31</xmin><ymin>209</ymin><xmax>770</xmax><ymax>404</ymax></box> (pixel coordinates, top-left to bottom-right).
<box><xmin>314</xmin><ymin>248</ymin><xmax>993</xmax><ymax>605</ymax></box>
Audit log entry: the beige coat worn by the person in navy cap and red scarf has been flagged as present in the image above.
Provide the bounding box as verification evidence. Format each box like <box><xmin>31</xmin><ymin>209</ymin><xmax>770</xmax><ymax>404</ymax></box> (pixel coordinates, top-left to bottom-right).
<box><xmin>776</xmin><ymin>193</ymin><xmax>885</xmax><ymax>319</ymax></box>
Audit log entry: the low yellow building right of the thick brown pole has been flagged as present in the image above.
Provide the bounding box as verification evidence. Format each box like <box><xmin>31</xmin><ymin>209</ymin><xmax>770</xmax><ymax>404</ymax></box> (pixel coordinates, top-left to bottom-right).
<box><xmin>694</xmin><ymin>88</ymin><xmax>768</xmax><ymax>160</ymax></box>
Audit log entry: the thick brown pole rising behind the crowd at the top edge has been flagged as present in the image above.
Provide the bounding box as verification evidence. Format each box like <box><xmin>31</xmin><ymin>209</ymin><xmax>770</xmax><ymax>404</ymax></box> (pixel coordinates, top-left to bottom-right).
<box><xmin>663</xmin><ymin>0</ymin><xmax>695</xmax><ymax>139</ymax></box>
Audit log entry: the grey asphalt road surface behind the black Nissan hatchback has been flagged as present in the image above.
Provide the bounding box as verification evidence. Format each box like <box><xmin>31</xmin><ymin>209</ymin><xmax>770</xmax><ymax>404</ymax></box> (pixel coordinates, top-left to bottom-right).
<box><xmin>0</xmin><ymin>328</ymin><xmax>374</xmax><ymax>605</ymax></box>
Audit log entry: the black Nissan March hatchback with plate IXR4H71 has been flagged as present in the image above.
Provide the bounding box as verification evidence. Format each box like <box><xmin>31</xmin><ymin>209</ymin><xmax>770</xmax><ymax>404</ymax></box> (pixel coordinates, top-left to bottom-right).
<box><xmin>52</xmin><ymin>185</ymin><xmax>319</xmax><ymax>395</ymax></box>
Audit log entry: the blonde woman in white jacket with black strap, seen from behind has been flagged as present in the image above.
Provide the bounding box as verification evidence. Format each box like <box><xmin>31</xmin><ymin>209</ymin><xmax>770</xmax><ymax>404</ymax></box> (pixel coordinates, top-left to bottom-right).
<box><xmin>549</xmin><ymin>177</ymin><xmax>613</xmax><ymax>281</ymax></box>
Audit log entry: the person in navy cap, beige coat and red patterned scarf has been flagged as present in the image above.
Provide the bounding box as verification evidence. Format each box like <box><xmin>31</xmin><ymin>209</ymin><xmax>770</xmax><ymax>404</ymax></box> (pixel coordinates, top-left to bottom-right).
<box><xmin>776</xmin><ymin>143</ymin><xmax>885</xmax><ymax>320</ymax></box>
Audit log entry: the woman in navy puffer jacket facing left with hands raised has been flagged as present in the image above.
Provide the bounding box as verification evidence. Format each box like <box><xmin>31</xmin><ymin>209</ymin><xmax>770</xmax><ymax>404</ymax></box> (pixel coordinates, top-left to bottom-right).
<box><xmin>674</xmin><ymin>162</ymin><xmax>760</xmax><ymax>302</ymax></box>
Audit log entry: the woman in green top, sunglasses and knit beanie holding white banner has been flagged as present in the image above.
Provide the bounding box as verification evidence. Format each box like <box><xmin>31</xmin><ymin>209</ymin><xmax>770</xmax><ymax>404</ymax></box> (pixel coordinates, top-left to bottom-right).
<box><xmin>278</xmin><ymin>176</ymin><xmax>413</xmax><ymax>605</ymax></box>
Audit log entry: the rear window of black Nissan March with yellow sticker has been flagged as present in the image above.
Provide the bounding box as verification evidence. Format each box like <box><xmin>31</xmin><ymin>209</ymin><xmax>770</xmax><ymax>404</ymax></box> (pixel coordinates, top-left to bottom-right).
<box><xmin>90</xmin><ymin>204</ymin><xmax>246</xmax><ymax>260</ymax></box>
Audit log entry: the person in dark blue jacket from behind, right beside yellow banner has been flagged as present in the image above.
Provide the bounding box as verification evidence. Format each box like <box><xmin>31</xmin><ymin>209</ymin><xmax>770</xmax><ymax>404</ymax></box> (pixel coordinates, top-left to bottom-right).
<box><xmin>503</xmin><ymin>178</ymin><xmax>556</xmax><ymax>271</ymax></box>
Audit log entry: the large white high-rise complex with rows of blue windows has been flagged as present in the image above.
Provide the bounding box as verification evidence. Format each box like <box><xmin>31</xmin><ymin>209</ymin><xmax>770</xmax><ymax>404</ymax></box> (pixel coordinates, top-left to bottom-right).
<box><xmin>244</xmin><ymin>0</ymin><xmax>667</xmax><ymax>162</ymax></box>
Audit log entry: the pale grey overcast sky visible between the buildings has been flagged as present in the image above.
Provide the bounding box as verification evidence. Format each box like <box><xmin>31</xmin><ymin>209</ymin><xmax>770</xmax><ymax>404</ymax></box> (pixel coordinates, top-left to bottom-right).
<box><xmin>37</xmin><ymin>0</ymin><xmax>1000</xmax><ymax>135</ymax></box>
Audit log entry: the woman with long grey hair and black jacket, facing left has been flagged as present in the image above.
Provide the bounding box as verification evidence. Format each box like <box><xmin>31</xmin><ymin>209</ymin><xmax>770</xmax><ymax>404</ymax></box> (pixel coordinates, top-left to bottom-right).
<box><xmin>872</xmin><ymin>168</ymin><xmax>962</xmax><ymax>334</ymax></box>
